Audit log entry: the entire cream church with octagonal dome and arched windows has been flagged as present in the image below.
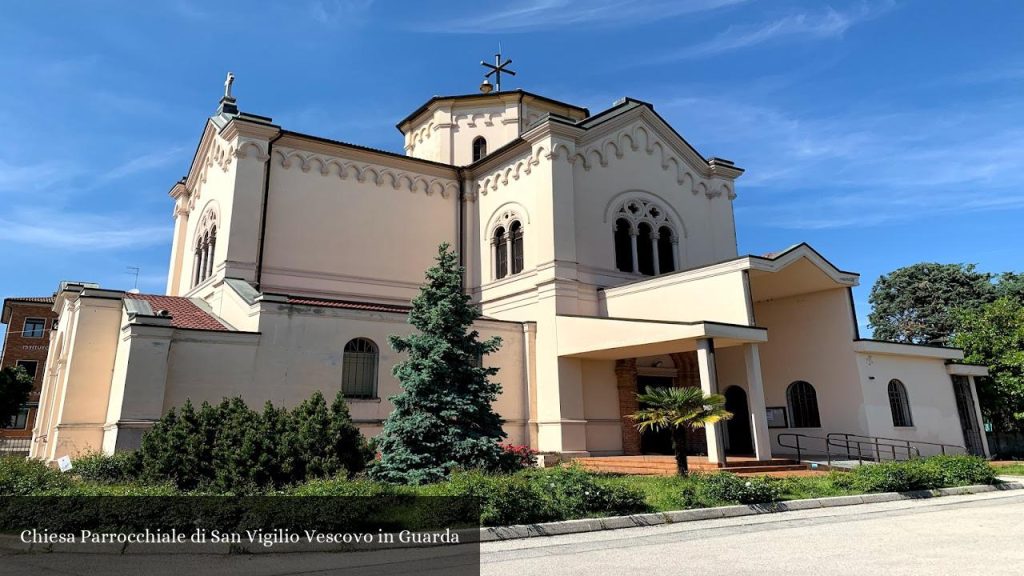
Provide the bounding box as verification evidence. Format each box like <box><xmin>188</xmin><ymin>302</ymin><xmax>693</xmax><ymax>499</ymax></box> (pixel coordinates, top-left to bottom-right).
<box><xmin>32</xmin><ymin>80</ymin><xmax>987</xmax><ymax>462</ymax></box>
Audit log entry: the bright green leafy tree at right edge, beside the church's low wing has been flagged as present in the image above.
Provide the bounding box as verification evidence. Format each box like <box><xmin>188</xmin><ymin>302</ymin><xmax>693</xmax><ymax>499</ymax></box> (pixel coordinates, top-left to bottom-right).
<box><xmin>952</xmin><ymin>297</ymin><xmax>1024</xmax><ymax>430</ymax></box>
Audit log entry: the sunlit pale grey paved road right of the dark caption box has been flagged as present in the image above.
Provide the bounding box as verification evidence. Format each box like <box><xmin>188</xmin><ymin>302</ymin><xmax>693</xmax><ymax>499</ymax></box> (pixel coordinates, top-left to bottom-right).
<box><xmin>482</xmin><ymin>492</ymin><xmax>1024</xmax><ymax>576</ymax></box>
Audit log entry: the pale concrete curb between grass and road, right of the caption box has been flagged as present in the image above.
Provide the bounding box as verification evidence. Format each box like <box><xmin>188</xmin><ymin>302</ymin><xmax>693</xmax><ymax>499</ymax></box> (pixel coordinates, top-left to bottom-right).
<box><xmin>480</xmin><ymin>482</ymin><xmax>1024</xmax><ymax>542</ymax></box>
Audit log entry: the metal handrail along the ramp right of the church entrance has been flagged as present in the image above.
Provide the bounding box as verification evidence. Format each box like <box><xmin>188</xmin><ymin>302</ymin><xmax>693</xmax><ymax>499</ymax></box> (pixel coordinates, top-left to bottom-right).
<box><xmin>775</xmin><ymin>433</ymin><xmax>966</xmax><ymax>467</ymax></box>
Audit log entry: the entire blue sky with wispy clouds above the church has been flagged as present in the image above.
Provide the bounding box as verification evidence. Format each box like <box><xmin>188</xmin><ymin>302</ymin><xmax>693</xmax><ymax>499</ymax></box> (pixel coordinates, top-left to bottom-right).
<box><xmin>0</xmin><ymin>0</ymin><xmax>1024</xmax><ymax>336</ymax></box>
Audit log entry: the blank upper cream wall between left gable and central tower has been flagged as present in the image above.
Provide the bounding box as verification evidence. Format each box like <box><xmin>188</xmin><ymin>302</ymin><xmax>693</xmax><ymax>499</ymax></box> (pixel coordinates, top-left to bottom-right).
<box><xmin>261</xmin><ymin>139</ymin><xmax>458</xmax><ymax>302</ymax></box>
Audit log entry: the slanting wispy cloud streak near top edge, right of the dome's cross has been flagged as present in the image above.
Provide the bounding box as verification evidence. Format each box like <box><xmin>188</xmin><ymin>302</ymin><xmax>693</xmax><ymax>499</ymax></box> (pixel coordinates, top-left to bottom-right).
<box><xmin>658</xmin><ymin>1</ymin><xmax>894</xmax><ymax>61</ymax></box>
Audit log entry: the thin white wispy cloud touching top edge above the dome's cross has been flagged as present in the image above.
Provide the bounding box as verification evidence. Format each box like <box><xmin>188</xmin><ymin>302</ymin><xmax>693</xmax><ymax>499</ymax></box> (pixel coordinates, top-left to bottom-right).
<box><xmin>414</xmin><ymin>0</ymin><xmax>746</xmax><ymax>34</ymax></box>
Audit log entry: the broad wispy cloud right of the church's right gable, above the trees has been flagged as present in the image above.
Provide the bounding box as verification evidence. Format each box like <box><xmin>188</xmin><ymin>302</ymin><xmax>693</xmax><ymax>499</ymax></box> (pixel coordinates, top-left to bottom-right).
<box><xmin>658</xmin><ymin>91</ymin><xmax>1024</xmax><ymax>230</ymax></box>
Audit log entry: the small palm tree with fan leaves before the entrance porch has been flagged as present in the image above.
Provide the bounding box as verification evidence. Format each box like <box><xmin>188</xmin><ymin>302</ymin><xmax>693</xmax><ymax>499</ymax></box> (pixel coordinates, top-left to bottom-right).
<box><xmin>630</xmin><ymin>386</ymin><xmax>732</xmax><ymax>476</ymax></box>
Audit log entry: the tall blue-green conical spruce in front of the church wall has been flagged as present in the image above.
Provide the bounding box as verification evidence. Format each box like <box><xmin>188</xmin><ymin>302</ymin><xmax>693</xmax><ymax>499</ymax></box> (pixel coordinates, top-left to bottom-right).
<box><xmin>371</xmin><ymin>239</ymin><xmax>505</xmax><ymax>484</ymax></box>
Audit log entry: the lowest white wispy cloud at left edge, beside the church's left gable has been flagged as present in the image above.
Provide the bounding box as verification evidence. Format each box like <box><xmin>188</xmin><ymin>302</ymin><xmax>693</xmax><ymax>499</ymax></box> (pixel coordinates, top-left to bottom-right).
<box><xmin>0</xmin><ymin>209</ymin><xmax>171</xmax><ymax>251</ymax></box>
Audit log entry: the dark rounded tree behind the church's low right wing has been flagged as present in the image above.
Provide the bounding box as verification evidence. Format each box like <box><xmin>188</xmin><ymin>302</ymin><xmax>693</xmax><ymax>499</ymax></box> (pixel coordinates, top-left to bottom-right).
<box><xmin>868</xmin><ymin>262</ymin><xmax>994</xmax><ymax>343</ymax></box>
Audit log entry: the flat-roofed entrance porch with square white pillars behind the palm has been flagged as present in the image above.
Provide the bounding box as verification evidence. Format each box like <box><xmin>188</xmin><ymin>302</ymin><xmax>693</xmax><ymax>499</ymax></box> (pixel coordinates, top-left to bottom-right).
<box><xmin>558</xmin><ymin>316</ymin><xmax>772</xmax><ymax>468</ymax></box>
